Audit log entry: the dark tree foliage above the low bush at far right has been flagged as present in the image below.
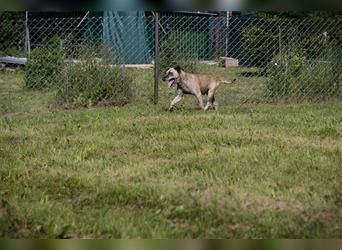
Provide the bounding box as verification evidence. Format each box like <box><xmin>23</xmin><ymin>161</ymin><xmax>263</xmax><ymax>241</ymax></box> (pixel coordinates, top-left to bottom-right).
<box><xmin>241</xmin><ymin>12</ymin><xmax>342</xmax><ymax>67</ymax></box>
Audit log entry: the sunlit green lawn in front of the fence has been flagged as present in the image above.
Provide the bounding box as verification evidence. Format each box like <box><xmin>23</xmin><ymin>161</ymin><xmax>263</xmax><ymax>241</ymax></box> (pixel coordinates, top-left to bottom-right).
<box><xmin>0</xmin><ymin>71</ymin><xmax>342</xmax><ymax>238</ymax></box>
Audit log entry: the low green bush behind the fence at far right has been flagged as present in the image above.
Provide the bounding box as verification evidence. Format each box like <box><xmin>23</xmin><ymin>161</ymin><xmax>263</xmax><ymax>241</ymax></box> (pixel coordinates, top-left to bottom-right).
<box><xmin>266</xmin><ymin>46</ymin><xmax>342</xmax><ymax>100</ymax></box>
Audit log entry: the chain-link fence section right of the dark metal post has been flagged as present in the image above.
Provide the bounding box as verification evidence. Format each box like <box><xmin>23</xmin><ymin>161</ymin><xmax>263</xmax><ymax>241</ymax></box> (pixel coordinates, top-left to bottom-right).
<box><xmin>161</xmin><ymin>15</ymin><xmax>342</xmax><ymax>104</ymax></box>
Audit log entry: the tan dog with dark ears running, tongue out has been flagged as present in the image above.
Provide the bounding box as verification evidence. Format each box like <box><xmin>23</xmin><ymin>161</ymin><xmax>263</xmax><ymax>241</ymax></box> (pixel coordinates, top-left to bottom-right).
<box><xmin>163</xmin><ymin>66</ymin><xmax>236</xmax><ymax>111</ymax></box>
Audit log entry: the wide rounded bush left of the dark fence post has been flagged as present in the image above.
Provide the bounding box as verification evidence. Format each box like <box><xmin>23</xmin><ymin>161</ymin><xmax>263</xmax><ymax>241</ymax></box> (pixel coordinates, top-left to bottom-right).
<box><xmin>57</xmin><ymin>59</ymin><xmax>132</xmax><ymax>107</ymax></box>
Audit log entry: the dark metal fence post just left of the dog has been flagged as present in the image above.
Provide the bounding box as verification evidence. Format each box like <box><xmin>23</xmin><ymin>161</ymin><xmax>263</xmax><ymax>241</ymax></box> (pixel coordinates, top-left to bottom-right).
<box><xmin>153</xmin><ymin>12</ymin><xmax>159</xmax><ymax>104</ymax></box>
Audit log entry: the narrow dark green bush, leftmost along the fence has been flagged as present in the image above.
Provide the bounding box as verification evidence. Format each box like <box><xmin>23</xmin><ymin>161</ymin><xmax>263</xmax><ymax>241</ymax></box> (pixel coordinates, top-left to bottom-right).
<box><xmin>25</xmin><ymin>37</ymin><xmax>63</xmax><ymax>89</ymax></box>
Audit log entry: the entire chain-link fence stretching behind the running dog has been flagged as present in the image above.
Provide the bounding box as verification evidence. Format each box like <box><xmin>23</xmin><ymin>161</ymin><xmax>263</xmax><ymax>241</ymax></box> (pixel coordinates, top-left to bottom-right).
<box><xmin>0</xmin><ymin>12</ymin><xmax>342</xmax><ymax>109</ymax></box>
